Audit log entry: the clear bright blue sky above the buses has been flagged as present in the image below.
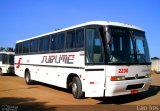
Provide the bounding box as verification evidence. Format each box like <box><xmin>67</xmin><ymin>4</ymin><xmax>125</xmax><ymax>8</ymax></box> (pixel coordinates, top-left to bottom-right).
<box><xmin>0</xmin><ymin>0</ymin><xmax>160</xmax><ymax>57</ymax></box>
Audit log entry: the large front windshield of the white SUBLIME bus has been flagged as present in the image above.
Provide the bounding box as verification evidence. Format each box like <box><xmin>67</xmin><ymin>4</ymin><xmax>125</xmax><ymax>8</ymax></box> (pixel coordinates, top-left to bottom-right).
<box><xmin>107</xmin><ymin>27</ymin><xmax>150</xmax><ymax>64</ymax></box>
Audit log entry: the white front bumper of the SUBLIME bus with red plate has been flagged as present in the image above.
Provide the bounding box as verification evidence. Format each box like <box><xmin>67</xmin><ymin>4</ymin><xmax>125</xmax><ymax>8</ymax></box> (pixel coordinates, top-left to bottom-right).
<box><xmin>105</xmin><ymin>78</ymin><xmax>151</xmax><ymax>97</ymax></box>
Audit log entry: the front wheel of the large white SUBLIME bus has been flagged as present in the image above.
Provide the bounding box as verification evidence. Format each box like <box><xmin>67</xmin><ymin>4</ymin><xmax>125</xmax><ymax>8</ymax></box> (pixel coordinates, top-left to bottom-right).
<box><xmin>72</xmin><ymin>77</ymin><xmax>83</xmax><ymax>99</ymax></box>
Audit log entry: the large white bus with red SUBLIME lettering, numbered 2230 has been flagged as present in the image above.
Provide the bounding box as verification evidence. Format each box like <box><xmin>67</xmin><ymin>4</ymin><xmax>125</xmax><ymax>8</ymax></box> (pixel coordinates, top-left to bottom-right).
<box><xmin>15</xmin><ymin>21</ymin><xmax>151</xmax><ymax>99</ymax></box>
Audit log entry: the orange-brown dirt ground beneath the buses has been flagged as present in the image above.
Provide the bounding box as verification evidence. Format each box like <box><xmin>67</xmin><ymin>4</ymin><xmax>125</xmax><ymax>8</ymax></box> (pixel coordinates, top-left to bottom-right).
<box><xmin>0</xmin><ymin>74</ymin><xmax>160</xmax><ymax>111</ymax></box>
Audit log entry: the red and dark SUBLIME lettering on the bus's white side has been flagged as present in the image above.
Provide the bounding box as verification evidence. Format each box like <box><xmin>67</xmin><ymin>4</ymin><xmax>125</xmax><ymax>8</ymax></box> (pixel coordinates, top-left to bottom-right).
<box><xmin>41</xmin><ymin>55</ymin><xmax>75</xmax><ymax>64</ymax></box>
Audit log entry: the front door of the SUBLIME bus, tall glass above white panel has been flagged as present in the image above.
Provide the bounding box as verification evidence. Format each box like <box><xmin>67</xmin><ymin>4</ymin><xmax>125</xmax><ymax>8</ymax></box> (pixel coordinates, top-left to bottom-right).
<box><xmin>85</xmin><ymin>28</ymin><xmax>106</xmax><ymax>97</ymax></box>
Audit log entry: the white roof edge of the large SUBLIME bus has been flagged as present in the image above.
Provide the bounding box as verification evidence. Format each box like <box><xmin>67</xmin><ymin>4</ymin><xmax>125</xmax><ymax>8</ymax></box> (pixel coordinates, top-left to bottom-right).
<box><xmin>16</xmin><ymin>21</ymin><xmax>144</xmax><ymax>43</ymax></box>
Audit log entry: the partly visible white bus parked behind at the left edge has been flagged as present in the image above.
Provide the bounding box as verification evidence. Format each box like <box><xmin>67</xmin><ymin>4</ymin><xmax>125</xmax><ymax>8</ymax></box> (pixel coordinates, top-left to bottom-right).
<box><xmin>0</xmin><ymin>52</ymin><xmax>15</xmax><ymax>76</ymax></box>
